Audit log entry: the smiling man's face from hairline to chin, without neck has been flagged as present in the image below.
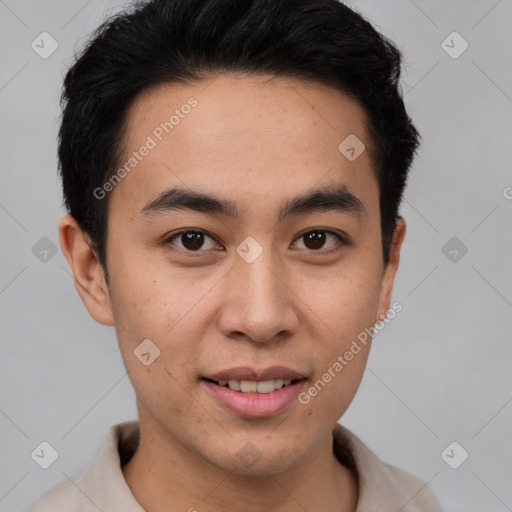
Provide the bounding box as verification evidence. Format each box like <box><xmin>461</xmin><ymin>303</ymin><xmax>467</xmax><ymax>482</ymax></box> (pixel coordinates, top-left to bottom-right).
<box><xmin>73</xmin><ymin>74</ymin><xmax>400</xmax><ymax>474</ymax></box>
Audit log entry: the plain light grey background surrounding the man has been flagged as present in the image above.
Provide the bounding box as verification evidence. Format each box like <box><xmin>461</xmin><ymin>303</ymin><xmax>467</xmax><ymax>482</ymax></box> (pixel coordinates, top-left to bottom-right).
<box><xmin>0</xmin><ymin>0</ymin><xmax>512</xmax><ymax>512</ymax></box>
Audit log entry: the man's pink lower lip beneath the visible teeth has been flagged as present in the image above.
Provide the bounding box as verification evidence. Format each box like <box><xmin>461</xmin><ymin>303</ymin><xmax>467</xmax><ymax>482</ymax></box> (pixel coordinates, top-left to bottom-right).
<box><xmin>202</xmin><ymin>379</ymin><xmax>306</xmax><ymax>418</ymax></box>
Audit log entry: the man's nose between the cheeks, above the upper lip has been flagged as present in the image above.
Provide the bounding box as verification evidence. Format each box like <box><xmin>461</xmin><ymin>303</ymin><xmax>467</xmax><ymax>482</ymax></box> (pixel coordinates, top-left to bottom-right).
<box><xmin>218</xmin><ymin>250</ymin><xmax>298</xmax><ymax>343</ymax></box>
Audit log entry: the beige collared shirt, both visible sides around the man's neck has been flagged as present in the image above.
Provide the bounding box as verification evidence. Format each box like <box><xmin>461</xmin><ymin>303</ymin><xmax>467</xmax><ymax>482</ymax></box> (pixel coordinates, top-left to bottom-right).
<box><xmin>24</xmin><ymin>421</ymin><xmax>440</xmax><ymax>512</ymax></box>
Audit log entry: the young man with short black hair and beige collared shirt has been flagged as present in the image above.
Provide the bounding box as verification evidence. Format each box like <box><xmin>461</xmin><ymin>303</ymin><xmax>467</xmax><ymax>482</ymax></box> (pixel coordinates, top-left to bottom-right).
<box><xmin>27</xmin><ymin>0</ymin><xmax>439</xmax><ymax>512</ymax></box>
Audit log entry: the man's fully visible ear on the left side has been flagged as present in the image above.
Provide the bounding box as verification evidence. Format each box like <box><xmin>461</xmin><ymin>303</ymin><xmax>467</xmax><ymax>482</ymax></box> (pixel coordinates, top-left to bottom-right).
<box><xmin>59</xmin><ymin>215</ymin><xmax>115</xmax><ymax>325</ymax></box>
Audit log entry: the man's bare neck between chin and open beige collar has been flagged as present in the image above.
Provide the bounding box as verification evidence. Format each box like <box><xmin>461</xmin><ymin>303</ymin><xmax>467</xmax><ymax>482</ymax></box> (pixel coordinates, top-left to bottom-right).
<box><xmin>122</xmin><ymin>416</ymin><xmax>358</xmax><ymax>512</ymax></box>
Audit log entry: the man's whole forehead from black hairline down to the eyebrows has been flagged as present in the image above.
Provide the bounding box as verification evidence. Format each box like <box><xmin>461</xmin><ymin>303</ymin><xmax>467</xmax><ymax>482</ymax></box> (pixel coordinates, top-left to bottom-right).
<box><xmin>113</xmin><ymin>74</ymin><xmax>377</xmax><ymax>218</ymax></box>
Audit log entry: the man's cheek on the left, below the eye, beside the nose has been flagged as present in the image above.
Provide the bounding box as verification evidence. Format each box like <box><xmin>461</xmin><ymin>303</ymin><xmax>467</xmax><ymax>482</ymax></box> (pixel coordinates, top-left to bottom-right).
<box><xmin>106</xmin><ymin>253</ymin><xmax>204</xmax><ymax>392</ymax></box>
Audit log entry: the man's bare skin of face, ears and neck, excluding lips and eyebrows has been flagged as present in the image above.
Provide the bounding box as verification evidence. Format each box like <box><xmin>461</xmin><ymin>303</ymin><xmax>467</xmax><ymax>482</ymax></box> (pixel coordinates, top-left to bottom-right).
<box><xmin>59</xmin><ymin>73</ymin><xmax>405</xmax><ymax>512</ymax></box>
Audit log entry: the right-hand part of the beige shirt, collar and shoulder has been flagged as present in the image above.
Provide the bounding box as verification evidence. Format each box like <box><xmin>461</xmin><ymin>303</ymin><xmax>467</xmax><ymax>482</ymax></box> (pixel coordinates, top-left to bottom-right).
<box><xmin>333</xmin><ymin>423</ymin><xmax>440</xmax><ymax>512</ymax></box>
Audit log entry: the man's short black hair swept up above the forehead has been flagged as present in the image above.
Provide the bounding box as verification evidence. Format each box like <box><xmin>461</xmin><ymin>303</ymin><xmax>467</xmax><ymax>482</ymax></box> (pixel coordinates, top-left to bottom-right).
<box><xmin>58</xmin><ymin>0</ymin><xmax>420</xmax><ymax>279</ymax></box>
